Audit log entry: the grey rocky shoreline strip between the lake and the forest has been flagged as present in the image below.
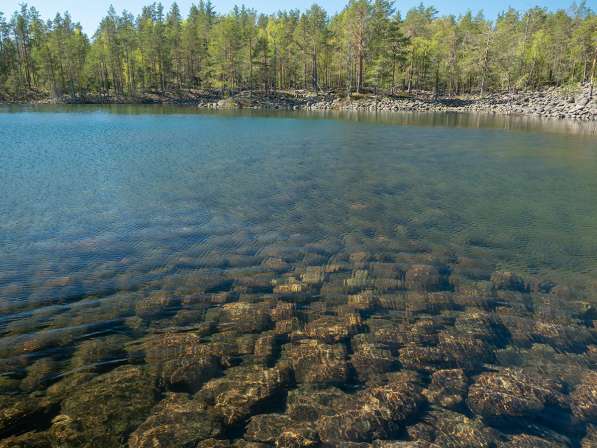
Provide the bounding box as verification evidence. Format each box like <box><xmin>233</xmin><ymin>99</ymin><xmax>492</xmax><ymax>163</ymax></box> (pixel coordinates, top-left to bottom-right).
<box><xmin>0</xmin><ymin>85</ymin><xmax>597</xmax><ymax>121</ymax></box>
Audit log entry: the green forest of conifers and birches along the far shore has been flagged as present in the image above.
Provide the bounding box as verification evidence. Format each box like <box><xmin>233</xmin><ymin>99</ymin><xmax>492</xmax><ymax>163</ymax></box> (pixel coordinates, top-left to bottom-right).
<box><xmin>0</xmin><ymin>0</ymin><xmax>597</xmax><ymax>98</ymax></box>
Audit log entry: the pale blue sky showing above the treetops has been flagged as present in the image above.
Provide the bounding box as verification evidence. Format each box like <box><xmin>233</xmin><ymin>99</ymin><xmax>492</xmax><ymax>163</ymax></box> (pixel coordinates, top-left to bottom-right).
<box><xmin>0</xmin><ymin>0</ymin><xmax>597</xmax><ymax>34</ymax></box>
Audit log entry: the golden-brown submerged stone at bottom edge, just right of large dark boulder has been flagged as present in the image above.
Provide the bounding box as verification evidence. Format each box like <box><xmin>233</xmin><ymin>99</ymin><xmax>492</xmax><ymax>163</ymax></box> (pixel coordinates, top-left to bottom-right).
<box><xmin>128</xmin><ymin>394</ymin><xmax>222</xmax><ymax>448</ymax></box>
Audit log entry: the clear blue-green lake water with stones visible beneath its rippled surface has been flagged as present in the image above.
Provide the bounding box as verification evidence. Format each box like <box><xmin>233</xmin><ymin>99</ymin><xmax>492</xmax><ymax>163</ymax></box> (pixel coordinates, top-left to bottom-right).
<box><xmin>0</xmin><ymin>106</ymin><xmax>597</xmax><ymax>447</ymax></box>
